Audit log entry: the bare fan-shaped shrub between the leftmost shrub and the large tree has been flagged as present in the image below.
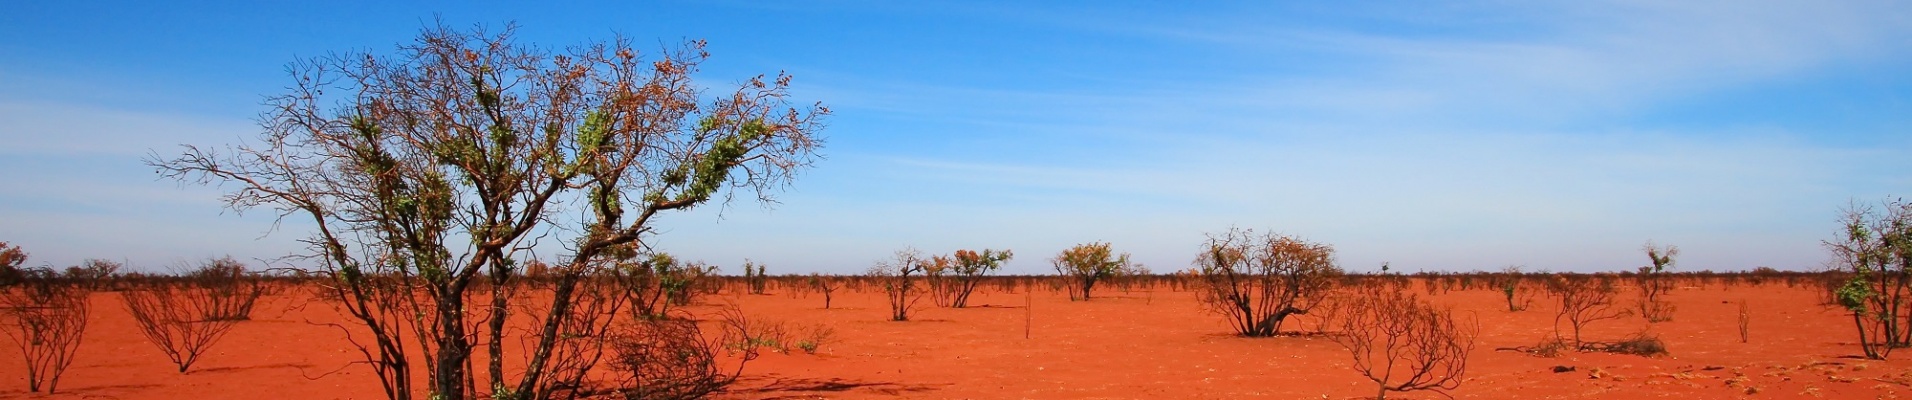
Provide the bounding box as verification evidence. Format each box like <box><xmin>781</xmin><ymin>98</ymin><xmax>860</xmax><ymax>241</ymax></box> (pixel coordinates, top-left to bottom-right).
<box><xmin>119</xmin><ymin>258</ymin><xmax>264</xmax><ymax>373</ymax></box>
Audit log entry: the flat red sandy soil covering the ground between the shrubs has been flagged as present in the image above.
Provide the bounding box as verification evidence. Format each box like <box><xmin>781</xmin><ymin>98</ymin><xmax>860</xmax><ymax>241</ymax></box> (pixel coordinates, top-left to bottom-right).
<box><xmin>0</xmin><ymin>285</ymin><xmax>1912</xmax><ymax>400</ymax></box>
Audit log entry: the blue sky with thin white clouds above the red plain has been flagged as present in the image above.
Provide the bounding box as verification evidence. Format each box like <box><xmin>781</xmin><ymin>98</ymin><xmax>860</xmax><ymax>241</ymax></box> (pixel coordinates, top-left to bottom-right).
<box><xmin>0</xmin><ymin>2</ymin><xmax>1912</xmax><ymax>274</ymax></box>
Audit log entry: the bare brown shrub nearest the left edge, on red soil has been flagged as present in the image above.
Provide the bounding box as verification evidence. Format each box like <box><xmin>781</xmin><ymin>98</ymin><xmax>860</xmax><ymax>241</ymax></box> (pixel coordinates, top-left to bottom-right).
<box><xmin>0</xmin><ymin>268</ymin><xmax>92</xmax><ymax>392</ymax></box>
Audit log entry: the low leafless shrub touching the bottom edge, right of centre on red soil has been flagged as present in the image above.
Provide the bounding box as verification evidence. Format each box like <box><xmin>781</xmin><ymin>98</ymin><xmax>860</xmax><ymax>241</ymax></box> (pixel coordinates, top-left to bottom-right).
<box><xmin>1331</xmin><ymin>287</ymin><xmax>1480</xmax><ymax>398</ymax></box>
